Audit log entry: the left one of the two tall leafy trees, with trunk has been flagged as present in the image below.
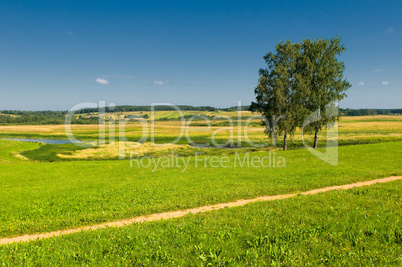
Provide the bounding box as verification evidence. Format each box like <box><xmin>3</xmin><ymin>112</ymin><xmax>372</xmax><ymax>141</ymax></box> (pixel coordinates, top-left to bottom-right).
<box><xmin>250</xmin><ymin>40</ymin><xmax>301</xmax><ymax>150</ymax></box>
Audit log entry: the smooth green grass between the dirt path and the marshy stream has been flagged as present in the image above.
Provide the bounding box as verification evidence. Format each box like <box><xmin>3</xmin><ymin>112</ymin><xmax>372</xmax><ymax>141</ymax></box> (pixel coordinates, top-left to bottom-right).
<box><xmin>0</xmin><ymin>142</ymin><xmax>402</xmax><ymax>237</ymax></box>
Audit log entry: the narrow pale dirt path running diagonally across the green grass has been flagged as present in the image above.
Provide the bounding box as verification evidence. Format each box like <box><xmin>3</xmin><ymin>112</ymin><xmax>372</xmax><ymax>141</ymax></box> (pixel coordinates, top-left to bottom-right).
<box><xmin>0</xmin><ymin>176</ymin><xmax>402</xmax><ymax>245</ymax></box>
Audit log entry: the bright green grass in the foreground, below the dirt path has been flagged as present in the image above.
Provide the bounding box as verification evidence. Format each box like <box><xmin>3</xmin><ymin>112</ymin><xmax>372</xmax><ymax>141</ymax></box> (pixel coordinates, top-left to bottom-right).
<box><xmin>0</xmin><ymin>181</ymin><xmax>402</xmax><ymax>266</ymax></box>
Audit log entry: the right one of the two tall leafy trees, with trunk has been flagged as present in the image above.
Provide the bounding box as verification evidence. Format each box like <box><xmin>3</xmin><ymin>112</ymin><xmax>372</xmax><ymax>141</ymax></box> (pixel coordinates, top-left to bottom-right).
<box><xmin>298</xmin><ymin>36</ymin><xmax>351</xmax><ymax>148</ymax></box>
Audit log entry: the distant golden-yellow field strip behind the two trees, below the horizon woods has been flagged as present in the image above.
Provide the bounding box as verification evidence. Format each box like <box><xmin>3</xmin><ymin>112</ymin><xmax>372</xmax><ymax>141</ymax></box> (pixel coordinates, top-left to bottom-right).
<box><xmin>0</xmin><ymin>111</ymin><xmax>402</xmax><ymax>147</ymax></box>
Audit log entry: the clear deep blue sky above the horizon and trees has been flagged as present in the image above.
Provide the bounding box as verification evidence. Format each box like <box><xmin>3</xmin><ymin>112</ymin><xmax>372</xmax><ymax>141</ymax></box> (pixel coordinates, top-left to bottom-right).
<box><xmin>0</xmin><ymin>0</ymin><xmax>402</xmax><ymax>110</ymax></box>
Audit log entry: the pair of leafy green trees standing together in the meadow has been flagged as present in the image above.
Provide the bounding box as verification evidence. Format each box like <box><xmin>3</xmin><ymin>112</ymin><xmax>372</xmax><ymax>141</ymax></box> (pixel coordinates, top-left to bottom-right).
<box><xmin>250</xmin><ymin>36</ymin><xmax>350</xmax><ymax>150</ymax></box>
